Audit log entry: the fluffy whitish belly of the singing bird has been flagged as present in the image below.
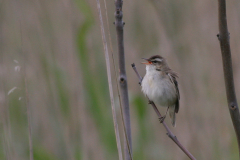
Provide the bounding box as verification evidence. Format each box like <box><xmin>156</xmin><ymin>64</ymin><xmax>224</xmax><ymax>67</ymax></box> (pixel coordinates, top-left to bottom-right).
<box><xmin>142</xmin><ymin>77</ymin><xmax>177</xmax><ymax>107</ymax></box>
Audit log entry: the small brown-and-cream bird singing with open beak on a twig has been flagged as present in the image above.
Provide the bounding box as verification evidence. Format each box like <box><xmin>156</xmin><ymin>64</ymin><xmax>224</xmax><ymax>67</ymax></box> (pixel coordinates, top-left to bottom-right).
<box><xmin>141</xmin><ymin>55</ymin><xmax>180</xmax><ymax>127</ymax></box>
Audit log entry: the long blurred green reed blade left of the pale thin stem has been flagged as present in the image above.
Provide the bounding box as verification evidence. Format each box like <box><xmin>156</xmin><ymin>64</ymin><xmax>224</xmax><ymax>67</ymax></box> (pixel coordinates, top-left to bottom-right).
<box><xmin>77</xmin><ymin>1</ymin><xmax>117</xmax><ymax>159</ymax></box>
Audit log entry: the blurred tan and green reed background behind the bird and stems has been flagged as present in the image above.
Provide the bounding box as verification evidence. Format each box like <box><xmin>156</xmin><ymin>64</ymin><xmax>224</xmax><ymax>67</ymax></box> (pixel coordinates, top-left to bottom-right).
<box><xmin>0</xmin><ymin>0</ymin><xmax>240</xmax><ymax>160</ymax></box>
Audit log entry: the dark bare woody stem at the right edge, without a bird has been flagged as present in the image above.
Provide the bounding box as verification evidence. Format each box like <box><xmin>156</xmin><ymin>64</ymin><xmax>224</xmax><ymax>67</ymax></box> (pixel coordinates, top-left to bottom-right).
<box><xmin>217</xmin><ymin>0</ymin><xmax>240</xmax><ymax>155</ymax></box>
